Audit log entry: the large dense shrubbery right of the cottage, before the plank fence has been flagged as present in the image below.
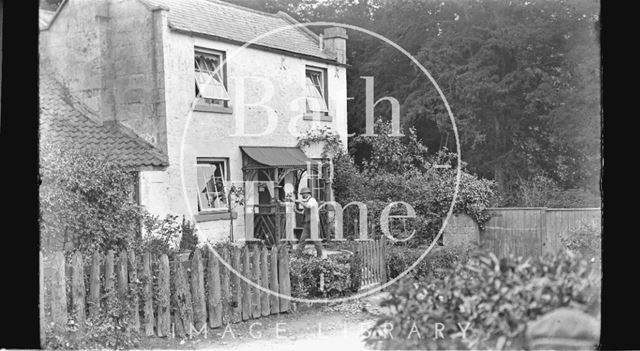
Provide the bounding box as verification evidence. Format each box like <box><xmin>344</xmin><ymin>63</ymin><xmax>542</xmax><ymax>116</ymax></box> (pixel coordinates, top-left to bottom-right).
<box><xmin>333</xmin><ymin>122</ymin><xmax>497</xmax><ymax>244</ymax></box>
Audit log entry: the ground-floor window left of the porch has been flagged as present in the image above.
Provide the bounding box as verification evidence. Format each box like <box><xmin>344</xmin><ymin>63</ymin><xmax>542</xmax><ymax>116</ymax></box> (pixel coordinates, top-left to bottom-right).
<box><xmin>197</xmin><ymin>158</ymin><xmax>228</xmax><ymax>212</ymax></box>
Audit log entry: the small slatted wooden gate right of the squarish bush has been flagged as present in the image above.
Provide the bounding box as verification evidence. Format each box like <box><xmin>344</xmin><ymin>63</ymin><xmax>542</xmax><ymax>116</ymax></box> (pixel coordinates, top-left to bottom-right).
<box><xmin>354</xmin><ymin>235</ymin><xmax>387</xmax><ymax>290</ymax></box>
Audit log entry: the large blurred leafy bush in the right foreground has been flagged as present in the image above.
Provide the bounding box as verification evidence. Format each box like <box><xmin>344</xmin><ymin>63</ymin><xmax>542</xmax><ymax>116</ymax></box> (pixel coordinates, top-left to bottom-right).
<box><xmin>367</xmin><ymin>251</ymin><xmax>600</xmax><ymax>349</ymax></box>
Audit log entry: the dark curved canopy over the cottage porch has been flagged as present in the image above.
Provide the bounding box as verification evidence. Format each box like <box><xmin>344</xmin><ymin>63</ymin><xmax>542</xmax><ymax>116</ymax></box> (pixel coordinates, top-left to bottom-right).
<box><xmin>240</xmin><ymin>146</ymin><xmax>315</xmax><ymax>169</ymax></box>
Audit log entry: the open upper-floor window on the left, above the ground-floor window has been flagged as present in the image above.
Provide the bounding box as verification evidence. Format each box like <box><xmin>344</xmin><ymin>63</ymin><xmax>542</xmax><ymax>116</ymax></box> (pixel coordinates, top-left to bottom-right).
<box><xmin>194</xmin><ymin>52</ymin><xmax>230</xmax><ymax>107</ymax></box>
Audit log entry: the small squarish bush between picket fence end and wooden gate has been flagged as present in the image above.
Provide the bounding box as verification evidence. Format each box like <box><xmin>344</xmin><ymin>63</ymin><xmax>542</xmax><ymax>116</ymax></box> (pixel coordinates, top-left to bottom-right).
<box><xmin>289</xmin><ymin>253</ymin><xmax>360</xmax><ymax>298</ymax></box>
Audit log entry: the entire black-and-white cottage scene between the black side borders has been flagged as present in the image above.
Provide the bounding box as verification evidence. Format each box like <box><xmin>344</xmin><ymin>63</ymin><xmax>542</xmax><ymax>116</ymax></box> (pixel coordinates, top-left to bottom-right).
<box><xmin>33</xmin><ymin>0</ymin><xmax>600</xmax><ymax>351</ymax></box>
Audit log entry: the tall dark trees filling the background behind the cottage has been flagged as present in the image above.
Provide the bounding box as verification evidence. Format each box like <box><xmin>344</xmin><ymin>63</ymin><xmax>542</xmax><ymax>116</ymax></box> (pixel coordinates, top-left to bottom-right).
<box><xmin>41</xmin><ymin>0</ymin><xmax>601</xmax><ymax>206</ymax></box>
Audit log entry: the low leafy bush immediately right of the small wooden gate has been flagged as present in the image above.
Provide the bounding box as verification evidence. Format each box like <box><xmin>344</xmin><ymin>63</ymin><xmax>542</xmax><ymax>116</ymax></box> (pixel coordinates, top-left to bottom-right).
<box><xmin>387</xmin><ymin>245</ymin><xmax>470</xmax><ymax>280</ymax></box>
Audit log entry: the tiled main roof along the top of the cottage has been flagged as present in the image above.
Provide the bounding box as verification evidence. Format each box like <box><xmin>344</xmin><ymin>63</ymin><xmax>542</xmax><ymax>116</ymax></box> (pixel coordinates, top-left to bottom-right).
<box><xmin>142</xmin><ymin>0</ymin><xmax>335</xmax><ymax>60</ymax></box>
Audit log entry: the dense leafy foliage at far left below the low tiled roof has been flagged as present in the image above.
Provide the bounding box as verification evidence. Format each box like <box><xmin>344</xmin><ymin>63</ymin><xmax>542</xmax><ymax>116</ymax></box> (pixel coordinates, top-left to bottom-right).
<box><xmin>39</xmin><ymin>143</ymin><xmax>145</xmax><ymax>252</ymax></box>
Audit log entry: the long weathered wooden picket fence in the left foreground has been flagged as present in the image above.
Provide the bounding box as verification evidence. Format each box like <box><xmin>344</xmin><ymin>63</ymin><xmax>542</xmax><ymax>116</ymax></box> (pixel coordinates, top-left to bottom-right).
<box><xmin>40</xmin><ymin>243</ymin><xmax>291</xmax><ymax>337</ymax></box>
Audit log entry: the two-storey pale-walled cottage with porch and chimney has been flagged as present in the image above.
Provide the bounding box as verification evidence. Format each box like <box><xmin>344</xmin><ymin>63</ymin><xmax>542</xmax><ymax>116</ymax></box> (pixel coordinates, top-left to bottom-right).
<box><xmin>40</xmin><ymin>0</ymin><xmax>347</xmax><ymax>245</ymax></box>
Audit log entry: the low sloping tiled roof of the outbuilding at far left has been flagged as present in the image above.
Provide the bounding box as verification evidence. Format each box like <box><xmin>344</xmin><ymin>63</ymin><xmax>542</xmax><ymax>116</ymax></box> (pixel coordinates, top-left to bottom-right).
<box><xmin>40</xmin><ymin>70</ymin><xmax>169</xmax><ymax>167</ymax></box>
